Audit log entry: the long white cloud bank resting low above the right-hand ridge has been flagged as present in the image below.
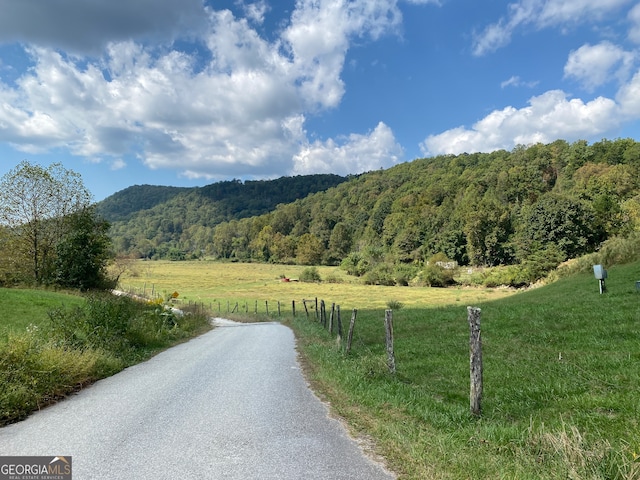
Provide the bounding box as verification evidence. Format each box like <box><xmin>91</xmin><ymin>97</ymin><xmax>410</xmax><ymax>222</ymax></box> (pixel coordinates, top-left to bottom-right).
<box><xmin>420</xmin><ymin>88</ymin><xmax>624</xmax><ymax>155</ymax></box>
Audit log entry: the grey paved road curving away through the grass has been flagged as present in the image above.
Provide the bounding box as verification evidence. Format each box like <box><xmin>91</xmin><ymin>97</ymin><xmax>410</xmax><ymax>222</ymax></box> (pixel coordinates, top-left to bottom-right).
<box><xmin>0</xmin><ymin>322</ymin><xmax>394</xmax><ymax>480</ymax></box>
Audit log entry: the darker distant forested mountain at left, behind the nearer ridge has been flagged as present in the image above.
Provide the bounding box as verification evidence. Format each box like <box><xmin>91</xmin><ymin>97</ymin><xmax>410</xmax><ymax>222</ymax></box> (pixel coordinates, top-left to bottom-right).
<box><xmin>101</xmin><ymin>175</ymin><xmax>347</xmax><ymax>258</ymax></box>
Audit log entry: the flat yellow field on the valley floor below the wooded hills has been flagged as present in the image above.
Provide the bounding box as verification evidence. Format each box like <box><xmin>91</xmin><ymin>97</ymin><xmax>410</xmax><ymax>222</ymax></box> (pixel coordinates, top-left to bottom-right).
<box><xmin>120</xmin><ymin>261</ymin><xmax>515</xmax><ymax>309</ymax></box>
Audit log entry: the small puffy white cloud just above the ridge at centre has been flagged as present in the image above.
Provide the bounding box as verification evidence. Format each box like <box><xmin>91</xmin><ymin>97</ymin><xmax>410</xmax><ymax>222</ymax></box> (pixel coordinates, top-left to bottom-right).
<box><xmin>293</xmin><ymin>122</ymin><xmax>403</xmax><ymax>175</ymax></box>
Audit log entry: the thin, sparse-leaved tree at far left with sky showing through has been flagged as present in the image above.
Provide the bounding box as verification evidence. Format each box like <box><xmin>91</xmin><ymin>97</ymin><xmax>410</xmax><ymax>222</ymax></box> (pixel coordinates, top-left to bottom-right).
<box><xmin>0</xmin><ymin>161</ymin><xmax>91</xmax><ymax>284</ymax></box>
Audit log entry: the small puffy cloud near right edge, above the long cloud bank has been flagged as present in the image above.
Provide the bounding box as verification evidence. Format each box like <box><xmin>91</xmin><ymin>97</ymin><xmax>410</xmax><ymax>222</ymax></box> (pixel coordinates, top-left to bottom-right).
<box><xmin>564</xmin><ymin>42</ymin><xmax>635</xmax><ymax>91</ymax></box>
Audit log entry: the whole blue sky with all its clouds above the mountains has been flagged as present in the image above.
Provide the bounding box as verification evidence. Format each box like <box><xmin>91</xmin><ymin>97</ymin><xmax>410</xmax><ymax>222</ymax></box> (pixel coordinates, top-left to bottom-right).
<box><xmin>0</xmin><ymin>0</ymin><xmax>640</xmax><ymax>201</ymax></box>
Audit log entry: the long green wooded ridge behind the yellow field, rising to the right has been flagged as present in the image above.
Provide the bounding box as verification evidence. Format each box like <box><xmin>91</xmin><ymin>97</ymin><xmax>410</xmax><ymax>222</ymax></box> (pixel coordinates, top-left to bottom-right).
<box><xmin>102</xmin><ymin>139</ymin><xmax>640</xmax><ymax>284</ymax></box>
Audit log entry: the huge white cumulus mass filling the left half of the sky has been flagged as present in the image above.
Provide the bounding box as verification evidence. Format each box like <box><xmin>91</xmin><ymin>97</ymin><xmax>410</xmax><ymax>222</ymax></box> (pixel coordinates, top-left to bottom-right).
<box><xmin>0</xmin><ymin>0</ymin><xmax>401</xmax><ymax>178</ymax></box>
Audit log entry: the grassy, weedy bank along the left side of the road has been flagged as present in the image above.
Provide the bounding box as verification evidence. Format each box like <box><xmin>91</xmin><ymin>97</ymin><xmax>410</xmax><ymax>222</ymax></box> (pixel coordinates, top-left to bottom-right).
<box><xmin>0</xmin><ymin>289</ymin><xmax>210</xmax><ymax>425</ymax></box>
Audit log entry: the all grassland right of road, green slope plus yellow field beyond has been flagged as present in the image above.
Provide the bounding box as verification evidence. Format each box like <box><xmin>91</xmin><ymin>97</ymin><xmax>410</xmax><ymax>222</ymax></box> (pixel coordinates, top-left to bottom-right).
<box><xmin>124</xmin><ymin>262</ymin><xmax>640</xmax><ymax>480</ymax></box>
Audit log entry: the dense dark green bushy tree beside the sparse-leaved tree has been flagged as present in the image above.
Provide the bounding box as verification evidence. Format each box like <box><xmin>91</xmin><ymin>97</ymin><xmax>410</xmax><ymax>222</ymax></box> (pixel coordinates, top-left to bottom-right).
<box><xmin>55</xmin><ymin>207</ymin><xmax>112</xmax><ymax>290</ymax></box>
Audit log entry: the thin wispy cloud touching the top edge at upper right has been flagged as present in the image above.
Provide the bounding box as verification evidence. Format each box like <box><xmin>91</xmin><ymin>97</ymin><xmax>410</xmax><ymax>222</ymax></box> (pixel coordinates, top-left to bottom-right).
<box><xmin>473</xmin><ymin>0</ymin><xmax>631</xmax><ymax>56</ymax></box>
